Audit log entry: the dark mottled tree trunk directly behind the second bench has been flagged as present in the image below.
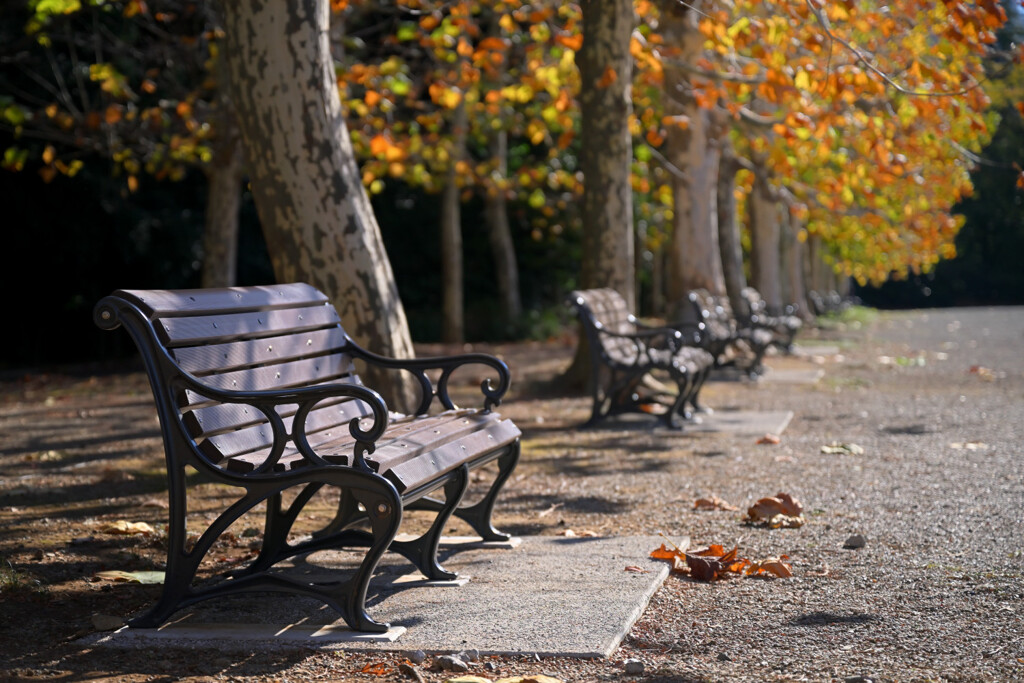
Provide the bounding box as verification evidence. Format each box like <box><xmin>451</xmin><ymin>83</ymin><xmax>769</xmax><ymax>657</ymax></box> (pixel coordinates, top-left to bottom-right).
<box><xmin>575</xmin><ymin>0</ymin><xmax>636</xmax><ymax>308</ymax></box>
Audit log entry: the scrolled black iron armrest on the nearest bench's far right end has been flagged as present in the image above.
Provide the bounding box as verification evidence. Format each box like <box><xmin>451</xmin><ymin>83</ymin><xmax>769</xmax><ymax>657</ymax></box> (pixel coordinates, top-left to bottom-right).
<box><xmin>347</xmin><ymin>344</ymin><xmax>512</xmax><ymax>415</ymax></box>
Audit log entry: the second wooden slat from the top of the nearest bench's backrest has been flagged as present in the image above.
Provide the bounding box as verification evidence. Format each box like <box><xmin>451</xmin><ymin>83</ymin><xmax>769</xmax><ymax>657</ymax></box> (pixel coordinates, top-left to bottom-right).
<box><xmin>157</xmin><ymin>305</ymin><xmax>340</xmax><ymax>348</ymax></box>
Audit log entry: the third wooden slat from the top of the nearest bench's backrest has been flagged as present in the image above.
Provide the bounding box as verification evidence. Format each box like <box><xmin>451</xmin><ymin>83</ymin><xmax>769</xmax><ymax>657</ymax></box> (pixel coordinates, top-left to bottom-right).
<box><xmin>173</xmin><ymin>327</ymin><xmax>347</xmax><ymax>376</ymax></box>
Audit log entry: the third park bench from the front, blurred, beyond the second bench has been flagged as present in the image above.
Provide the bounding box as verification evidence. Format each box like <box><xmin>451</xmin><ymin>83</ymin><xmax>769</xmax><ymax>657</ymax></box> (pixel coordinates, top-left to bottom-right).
<box><xmin>687</xmin><ymin>289</ymin><xmax>774</xmax><ymax>378</ymax></box>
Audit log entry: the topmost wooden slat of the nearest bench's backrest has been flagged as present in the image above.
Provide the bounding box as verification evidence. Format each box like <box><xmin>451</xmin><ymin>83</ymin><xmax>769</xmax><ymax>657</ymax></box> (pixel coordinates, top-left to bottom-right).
<box><xmin>115</xmin><ymin>283</ymin><xmax>328</xmax><ymax>317</ymax></box>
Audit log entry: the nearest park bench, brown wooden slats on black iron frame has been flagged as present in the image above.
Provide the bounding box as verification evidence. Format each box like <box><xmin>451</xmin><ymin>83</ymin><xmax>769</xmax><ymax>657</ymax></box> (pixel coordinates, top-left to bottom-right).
<box><xmin>94</xmin><ymin>284</ymin><xmax>520</xmax><ymax>632</ymax></box>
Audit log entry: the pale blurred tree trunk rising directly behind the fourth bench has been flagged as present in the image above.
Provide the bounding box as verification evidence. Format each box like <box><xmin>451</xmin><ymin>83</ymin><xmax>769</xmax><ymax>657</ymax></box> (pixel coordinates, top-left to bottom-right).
<box><xmin>748</xmin><ymin>158</ymin><xmax>782</xmax><ymax>308</ymax></box>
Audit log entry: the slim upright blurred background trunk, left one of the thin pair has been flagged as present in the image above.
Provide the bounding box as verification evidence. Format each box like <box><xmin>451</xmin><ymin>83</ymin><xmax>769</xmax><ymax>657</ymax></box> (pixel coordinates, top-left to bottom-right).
<box><xmin>440</xmin><ymin>98</ymin><xmax>467</xmax><ymax>344</ymax></box>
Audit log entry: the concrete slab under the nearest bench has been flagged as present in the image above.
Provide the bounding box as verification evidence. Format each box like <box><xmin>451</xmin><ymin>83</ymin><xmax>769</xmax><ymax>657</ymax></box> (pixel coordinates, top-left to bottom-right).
<box><xmin>91</xmin><ymin>537</ymin><xmax>669</xmax><ymax>657</ymax></box>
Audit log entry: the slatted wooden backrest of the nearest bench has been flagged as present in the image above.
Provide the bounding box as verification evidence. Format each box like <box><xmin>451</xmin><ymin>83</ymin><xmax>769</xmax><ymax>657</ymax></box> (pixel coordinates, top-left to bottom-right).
<box><xmin>97</xmin><ymin>283</ymin><xmax>372</xmax><ymax>469</ymax></box>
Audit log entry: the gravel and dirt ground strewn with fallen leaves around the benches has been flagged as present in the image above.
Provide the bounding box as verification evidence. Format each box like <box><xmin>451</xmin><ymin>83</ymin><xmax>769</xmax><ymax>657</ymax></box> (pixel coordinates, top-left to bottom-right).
<box><xmin>0</xmin><ymin>308</ymin><xmax>1024</xmax><ymax>682</ymax></box>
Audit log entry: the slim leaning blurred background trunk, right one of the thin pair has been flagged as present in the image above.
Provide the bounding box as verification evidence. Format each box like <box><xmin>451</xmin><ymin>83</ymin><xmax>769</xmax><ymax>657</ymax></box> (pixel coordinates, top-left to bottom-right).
<box><xmin>484</xmin><ymin>130</ymin><xmax>522</xmax><ymax>337</ymax></box>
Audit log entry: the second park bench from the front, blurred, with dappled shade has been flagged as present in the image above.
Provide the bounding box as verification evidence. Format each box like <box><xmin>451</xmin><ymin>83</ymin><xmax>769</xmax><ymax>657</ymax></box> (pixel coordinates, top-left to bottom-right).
<box><xmin>570</xmin><ymin>289</ymin><xmax>714</xmax><ymax>428</ymax></box>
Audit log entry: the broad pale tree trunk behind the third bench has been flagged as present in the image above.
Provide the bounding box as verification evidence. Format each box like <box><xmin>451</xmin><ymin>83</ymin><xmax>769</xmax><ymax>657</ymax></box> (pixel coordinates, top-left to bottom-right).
<box><xmin>662</xmin><ymin>0</ymin><xmax>726</xmax><ymax>306</ymax></box>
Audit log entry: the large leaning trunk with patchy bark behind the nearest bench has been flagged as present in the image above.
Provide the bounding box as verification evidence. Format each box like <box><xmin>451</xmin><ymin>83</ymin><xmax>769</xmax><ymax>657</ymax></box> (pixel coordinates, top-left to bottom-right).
<box><xmin>221</xmin><ymin>0</ymin><xmax>414</xmax><ymax>408</ymax></box>
